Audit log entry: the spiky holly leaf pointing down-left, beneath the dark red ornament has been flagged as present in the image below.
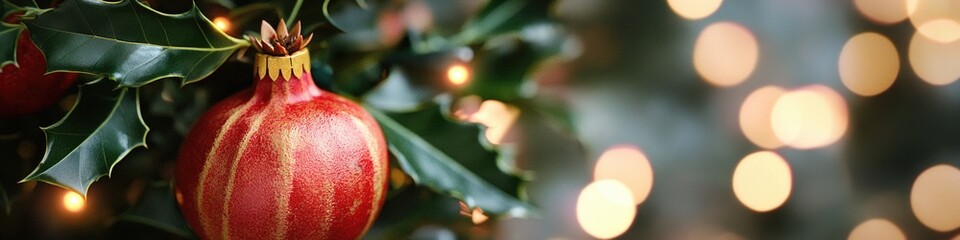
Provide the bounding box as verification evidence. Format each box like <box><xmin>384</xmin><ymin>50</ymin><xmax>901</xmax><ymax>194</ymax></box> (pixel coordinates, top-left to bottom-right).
<box><xmin>21</xmin><ymin>79</ymin><xmax>150</xmax><ymax>195</ymax></box>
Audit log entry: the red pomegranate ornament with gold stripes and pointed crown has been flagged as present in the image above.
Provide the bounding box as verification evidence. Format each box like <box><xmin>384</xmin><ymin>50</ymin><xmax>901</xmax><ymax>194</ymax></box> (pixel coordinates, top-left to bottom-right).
<box><xmin>174</xmin><ymin>21</ymin><xmax>388</xmax><ymax>239</ymax></box>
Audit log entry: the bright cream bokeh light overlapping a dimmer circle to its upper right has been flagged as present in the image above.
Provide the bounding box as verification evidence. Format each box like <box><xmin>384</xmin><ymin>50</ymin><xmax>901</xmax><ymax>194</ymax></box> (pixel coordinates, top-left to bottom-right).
<box><xmin>577</xmin><ymin>180</ymin><xmax>637</xmax><ymax>239</ymax></box>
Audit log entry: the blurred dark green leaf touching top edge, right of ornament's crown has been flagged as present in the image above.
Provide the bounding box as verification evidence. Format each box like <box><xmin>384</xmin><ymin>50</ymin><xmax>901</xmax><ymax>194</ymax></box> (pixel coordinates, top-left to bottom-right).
<box><xmin>455</xmin><ymin>0</ymin><xmax>554</xmax><ymax>44</ymax></box>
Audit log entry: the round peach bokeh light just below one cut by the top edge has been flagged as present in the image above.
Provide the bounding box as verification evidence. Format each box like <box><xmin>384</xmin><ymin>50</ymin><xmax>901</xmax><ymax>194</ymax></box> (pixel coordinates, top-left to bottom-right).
<box><xmin>693</xmin><ymin>22</ymin><xmax>760</xmax><ymax>87</ymax></box>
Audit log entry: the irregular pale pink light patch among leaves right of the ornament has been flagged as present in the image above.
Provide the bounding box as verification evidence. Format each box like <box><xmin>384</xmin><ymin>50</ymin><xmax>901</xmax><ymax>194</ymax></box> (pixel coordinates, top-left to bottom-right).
<box><xmin>468</xmin><ymin>100</ymin><xmax>520</xmax><ymax>145</ymax></box>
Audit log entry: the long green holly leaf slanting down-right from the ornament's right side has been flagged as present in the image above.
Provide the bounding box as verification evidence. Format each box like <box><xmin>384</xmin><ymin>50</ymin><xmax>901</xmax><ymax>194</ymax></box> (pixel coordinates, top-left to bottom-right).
<box><xmin>367</xmin><ymin>108</ymin><xmax>536</xmax><ymax>216</ymax></box>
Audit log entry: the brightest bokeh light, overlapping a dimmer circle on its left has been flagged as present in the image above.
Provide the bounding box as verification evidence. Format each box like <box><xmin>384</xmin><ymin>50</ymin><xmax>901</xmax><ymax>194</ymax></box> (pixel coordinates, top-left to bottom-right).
<box><xmin>770</xmin><ymin>85</ymin><xmax>849</xmax><ymax>149</ymax></box>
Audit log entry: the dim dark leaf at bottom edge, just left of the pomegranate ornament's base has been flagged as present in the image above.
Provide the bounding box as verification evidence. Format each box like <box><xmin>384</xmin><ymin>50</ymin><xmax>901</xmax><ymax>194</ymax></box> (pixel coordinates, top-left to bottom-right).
<box><xmin>117</xmin><ymin>182</ymin><xmax>197</xmax><ymax>239</ymax></box>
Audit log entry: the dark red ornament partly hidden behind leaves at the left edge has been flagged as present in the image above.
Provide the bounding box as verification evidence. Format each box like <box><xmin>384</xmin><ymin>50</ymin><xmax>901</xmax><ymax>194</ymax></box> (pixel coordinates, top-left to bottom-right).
<box><xmin>0</xmin><ymin>30</ymin><xmax>77</xmax><ymax>118</ymax></box>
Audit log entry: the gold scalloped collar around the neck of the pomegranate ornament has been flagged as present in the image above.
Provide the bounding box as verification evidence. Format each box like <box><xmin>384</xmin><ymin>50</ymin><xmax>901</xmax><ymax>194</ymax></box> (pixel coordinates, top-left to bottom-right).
<box><xmin>253</xmin><ymin>48</ymin><xmax>310</xmax><ymax>81</ymax></box>
